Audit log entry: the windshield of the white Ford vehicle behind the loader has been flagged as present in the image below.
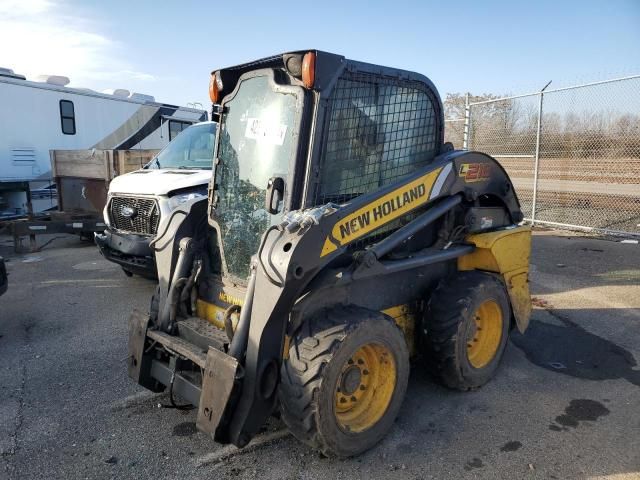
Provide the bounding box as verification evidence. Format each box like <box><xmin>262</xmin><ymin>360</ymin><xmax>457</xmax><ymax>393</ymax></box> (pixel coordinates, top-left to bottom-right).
<box><xmin>149</xmin><ymin>123</ymin><xmax>216</xmax><ymax>169</ymax></box>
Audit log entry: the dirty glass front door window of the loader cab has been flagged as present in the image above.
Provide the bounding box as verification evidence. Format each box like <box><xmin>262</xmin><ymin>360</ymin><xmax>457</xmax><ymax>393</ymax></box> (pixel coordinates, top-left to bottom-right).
<box><xmin>215</xmin><ymin>72</ymin><xmax>302</xmax><ymax>280</ymax></box>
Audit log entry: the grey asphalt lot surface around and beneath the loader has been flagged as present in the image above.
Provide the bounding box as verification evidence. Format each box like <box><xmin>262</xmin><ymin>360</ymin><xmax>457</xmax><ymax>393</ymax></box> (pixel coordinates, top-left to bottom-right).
<box><xmin>0</xmin><ymin>232</ymin><xmax>640</xmax><ymax>479</ymax></box>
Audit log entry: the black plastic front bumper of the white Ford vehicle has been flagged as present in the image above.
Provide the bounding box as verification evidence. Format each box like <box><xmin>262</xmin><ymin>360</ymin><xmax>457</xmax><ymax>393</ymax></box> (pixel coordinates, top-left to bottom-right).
<box><xmin>95</xmin><ymin>229</ymin><xmax>158</xmax><ymax>279</ymax></box>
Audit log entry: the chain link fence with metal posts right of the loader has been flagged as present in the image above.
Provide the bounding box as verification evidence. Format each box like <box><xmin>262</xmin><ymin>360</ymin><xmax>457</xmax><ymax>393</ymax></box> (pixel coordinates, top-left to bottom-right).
<box><xmin>445</xmin><ymin>75</ymin><xmax>640</xmax><ymax>236</ymax></box>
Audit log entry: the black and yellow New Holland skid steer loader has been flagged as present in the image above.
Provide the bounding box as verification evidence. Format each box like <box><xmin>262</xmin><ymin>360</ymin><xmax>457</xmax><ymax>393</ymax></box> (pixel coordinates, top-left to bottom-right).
<box><xmin>128</xmin><ymin>50</ymin><xmax>531</xmax><ymax>457</ymax></box>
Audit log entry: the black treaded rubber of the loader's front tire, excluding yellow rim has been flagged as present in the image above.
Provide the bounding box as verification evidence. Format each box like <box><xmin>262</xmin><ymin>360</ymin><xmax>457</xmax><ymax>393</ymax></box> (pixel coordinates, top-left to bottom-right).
<box><xmin>279</xmin><ymin>307</ymin><xmax>409</xmax><ymax>457</ymax></box>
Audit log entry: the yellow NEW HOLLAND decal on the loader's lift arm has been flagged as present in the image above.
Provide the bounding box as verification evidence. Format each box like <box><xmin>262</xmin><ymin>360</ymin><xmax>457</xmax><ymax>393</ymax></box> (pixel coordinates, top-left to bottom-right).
<box><xmin>320</xmin><ymin>167</ymin><xmax>442</xmax><ymax>257</ymax></box>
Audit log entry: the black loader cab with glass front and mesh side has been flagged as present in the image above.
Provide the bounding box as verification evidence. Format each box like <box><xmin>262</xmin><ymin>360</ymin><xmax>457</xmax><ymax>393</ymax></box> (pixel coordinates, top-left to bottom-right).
<box><xmin>209</xmin><ymin>51</ymin><xmax>443</xmax><ymax>283</ymax></box>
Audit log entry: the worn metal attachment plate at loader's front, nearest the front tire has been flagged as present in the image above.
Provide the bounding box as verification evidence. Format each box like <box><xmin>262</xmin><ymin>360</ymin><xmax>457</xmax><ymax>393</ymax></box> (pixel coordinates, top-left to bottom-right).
<box><xmin>196</xmin><ymin>348</ymin><xmax>238</xmax><ymax>437</ymax></box>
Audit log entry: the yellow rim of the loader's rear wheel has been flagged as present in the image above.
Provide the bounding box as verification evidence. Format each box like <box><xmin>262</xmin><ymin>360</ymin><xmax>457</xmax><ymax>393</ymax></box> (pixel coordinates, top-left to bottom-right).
<box><xmin>467</xmin><ymin>300</ymin><xmax>503</xmax><ymax>368</ymax></box>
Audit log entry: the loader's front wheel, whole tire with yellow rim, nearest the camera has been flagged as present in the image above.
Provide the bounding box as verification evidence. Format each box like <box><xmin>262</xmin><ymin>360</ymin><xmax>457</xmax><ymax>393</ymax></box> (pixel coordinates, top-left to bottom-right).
<box><xmin>279</xmin><ymin>307</ymin><xmax>409</xmax><ymax>457</ymax></box>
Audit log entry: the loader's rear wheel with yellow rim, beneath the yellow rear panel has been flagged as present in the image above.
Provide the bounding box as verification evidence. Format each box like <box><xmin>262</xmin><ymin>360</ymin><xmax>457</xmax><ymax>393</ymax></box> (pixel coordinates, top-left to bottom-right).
<box><xmin>421</xmin><ymin>271</ymin><xmax>511</xmax><ymax>390</ymax></box>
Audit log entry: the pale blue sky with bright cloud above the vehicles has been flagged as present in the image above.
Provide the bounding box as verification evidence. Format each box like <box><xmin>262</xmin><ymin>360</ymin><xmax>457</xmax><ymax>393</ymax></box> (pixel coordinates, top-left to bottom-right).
<box><xmin>0</xmin><ymin>0</ymin><xmax>640</xmax><ymax>108</ymax></box>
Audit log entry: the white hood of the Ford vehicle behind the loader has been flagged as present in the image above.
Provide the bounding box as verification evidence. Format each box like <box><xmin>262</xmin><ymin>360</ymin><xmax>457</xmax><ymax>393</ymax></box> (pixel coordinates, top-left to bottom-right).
<box><xmin>109</xmin><ymin>168</ymin><xmax>211</xmax><ymax>195</ymax></box>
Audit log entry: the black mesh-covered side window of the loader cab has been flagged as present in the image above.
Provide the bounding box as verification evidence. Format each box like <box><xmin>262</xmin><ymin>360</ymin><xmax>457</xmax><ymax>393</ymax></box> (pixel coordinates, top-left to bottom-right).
<box><xmin>315</xmin><ymin>73</ymin><xmax>438</xmax><ymax>205</ymax></box>
